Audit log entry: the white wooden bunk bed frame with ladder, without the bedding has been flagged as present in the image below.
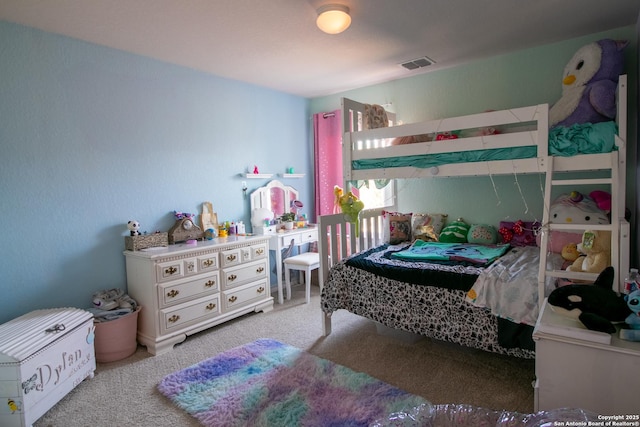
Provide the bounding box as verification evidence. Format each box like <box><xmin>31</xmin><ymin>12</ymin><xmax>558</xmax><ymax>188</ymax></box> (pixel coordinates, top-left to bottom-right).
<box><xmin>318</xmin><ymin>75</ymin><xmax>629</xmax><ymax>335</ymax></box>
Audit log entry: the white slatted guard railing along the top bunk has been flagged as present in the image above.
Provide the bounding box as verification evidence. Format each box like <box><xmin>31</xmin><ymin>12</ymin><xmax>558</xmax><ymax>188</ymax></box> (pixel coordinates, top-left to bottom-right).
<box><xmin>342</xmin><ymin>98</ymin><xmax>549</xmax><ymax>181</ymax></box>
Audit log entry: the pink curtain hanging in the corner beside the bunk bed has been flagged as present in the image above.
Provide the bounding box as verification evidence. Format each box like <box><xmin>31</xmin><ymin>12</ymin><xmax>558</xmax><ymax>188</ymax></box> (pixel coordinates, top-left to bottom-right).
<box><xmin>313</xmin><ymin>110</ymin><xmax>343</xmax><ymax>221</ymax></box>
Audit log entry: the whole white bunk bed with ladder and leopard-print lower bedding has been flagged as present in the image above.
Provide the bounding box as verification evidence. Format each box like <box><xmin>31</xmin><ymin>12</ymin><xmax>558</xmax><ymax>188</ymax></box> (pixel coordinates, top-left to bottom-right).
<box><xmin>318</xmin><ymin>76</ymin><xmax>629</xmax><ymax>358</ymax></box>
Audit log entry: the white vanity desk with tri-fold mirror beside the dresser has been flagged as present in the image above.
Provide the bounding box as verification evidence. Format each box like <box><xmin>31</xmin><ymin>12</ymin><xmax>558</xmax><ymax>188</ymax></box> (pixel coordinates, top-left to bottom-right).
<box><xmin>251</xmin><ymin>180</ymin><xmax>318</xmax><ymax>304</ymax></box>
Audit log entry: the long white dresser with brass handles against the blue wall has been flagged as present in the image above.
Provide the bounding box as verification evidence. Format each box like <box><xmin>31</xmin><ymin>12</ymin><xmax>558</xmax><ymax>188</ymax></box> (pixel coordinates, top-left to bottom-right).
<box><xmin>124</xmin><ymin>236</ymin><xmax>273</xmax><ymax>355</ymax></box>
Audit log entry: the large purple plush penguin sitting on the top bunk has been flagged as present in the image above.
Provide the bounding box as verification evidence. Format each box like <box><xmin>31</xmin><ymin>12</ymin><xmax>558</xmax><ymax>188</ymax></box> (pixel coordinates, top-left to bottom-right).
<box><xmin>549</xmin><ymin>39</ymin><xmax>628</xmax><ymax>128</ymax></box>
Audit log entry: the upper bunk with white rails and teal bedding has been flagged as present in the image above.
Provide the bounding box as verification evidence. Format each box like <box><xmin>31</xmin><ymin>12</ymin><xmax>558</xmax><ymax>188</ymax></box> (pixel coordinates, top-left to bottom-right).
<box><xmin>342</xmin><ymin>75</ymin><xmax>627</xmax><ymax>181</ymax></box>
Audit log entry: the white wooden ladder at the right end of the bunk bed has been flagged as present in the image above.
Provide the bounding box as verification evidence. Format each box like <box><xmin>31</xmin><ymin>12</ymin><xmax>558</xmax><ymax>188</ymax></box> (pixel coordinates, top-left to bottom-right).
<box><xmin>538</xmin><ymin>151</ymin><xmax>625</xmax><ymax>307</ymax></box>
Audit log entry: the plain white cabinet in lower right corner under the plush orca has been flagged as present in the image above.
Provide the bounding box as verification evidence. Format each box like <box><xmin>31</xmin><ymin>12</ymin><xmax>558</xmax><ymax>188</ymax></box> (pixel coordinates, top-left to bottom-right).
<box><xmin>533</xmin><ymin>300</ymin><xmax>640</xmax><ymax>414</ymax></box>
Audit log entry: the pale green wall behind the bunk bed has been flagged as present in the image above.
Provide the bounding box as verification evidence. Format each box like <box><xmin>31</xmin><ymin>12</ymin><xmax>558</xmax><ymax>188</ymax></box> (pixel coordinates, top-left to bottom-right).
<box><xmin>311</xmin><ymin>27</ymin><xmax>638</xmax><ymax>225</ymax></box>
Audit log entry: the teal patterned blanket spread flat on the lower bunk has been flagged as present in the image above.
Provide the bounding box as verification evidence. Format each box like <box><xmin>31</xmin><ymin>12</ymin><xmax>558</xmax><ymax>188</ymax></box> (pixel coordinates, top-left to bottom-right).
<box><xmin>391</xmin><ymin>240</ymin><xmax>510</xmax><ymax>266</ymax></box>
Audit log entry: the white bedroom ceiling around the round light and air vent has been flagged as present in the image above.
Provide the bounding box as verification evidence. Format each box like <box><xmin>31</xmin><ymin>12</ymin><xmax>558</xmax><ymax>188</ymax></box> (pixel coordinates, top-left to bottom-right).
<box><xmin>0</xmin><ymin>0</ymin><xmax>640</xmax><ymax>97</ymax></box>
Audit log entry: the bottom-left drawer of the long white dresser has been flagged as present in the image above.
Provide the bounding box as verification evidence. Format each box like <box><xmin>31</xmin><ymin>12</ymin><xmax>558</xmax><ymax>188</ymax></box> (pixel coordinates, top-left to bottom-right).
<box><xmin>160</xmin><ymin>294</ymin><xmax>220</xmax><ymax>334</ymax></box>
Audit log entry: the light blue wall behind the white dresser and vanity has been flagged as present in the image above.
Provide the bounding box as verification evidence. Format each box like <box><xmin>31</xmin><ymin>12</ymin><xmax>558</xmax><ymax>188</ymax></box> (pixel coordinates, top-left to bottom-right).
<box><xmin>0</xmin><ymin>22</ymin><xmax>313</xmax><ymax>323</ymax></box>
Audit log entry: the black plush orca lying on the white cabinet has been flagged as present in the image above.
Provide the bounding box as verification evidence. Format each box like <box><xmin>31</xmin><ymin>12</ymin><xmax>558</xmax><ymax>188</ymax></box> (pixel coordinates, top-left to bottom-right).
<box><xmin>547</xmin><ymin>266</ymin><xmax>631</xmax><ymax>334</ymax></box>
